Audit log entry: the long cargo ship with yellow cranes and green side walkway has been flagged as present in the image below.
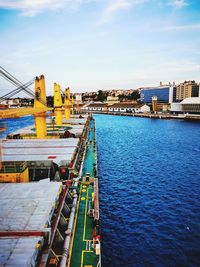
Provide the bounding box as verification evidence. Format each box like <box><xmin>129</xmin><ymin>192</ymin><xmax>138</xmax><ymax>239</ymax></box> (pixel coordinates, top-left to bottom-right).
<box><xmin>0</xmin><ymin>76</ymin><xmax>101</xmax><ymax>267</ymax></box>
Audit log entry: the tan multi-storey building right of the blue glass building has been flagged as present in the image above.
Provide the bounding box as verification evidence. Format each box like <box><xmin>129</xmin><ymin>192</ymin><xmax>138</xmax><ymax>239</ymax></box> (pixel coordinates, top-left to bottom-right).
<box><xmin>176</xmin><ymin>81</ymin><xmax>200</xmax><ymax>101</ymax></box>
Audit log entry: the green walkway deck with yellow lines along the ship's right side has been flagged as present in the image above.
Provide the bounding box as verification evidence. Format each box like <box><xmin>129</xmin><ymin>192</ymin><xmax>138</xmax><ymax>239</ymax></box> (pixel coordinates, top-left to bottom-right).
<box><xmin>68</xmin><ymin>121</ymin><xmax>99</xmax><ymax>267</ymax></box>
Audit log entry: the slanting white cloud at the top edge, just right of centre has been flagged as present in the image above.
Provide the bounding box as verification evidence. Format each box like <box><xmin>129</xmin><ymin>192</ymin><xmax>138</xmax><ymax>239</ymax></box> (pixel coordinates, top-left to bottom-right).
<box><xmin>98</xmin><ymin>0</ymin><xmax>145</xmax><ymax>25</ymax></box>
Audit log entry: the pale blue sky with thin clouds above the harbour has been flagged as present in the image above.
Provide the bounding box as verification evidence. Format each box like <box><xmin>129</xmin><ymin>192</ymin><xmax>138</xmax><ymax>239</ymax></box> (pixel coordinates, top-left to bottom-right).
<box><xmin>0</xmin><ymin>0</ymin><xmax>200</xmax><ymax>96</ymax></box>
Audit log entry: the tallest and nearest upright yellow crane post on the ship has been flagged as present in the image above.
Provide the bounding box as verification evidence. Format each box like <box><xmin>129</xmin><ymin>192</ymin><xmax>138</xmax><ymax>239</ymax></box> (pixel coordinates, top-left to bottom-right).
<box><xmin>34</xmin><ymin>75</ymin><xmax>47</xmax><ymax>138</ymax></box>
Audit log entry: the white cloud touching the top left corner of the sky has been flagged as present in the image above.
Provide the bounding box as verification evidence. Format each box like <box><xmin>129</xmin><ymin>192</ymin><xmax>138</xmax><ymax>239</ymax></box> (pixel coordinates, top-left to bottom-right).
<box><xmin>0</xmin><ymin>0</ymin><xmax>90</xmax><ymax>16</ymax></box>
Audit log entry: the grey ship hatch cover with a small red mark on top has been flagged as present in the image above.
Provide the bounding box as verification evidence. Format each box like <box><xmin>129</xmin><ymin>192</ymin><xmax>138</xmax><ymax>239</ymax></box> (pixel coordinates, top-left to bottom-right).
<box><xmin>2</xmin><ymin>138</ymin><xmax>79</xmax><ymax>165</ymax></box>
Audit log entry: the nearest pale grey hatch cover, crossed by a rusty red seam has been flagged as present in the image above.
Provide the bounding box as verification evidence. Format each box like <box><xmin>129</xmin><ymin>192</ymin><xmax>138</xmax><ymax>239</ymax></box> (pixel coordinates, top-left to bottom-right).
<box><xmin>0</xmin><ymin>180</ymin><xmax>62</xmax><ymax>267</ymax></box>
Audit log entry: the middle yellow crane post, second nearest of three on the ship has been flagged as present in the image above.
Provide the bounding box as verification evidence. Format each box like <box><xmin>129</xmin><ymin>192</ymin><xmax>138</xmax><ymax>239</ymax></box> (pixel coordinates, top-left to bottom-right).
<box><xmin>54</xmin><ymin>83</ymin><xmax>62</xmax><ymax>125</ymax></box>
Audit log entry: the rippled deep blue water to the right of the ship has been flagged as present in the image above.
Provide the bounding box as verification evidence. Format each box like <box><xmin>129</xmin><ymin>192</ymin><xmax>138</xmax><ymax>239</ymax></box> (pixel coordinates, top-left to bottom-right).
<box><xmin>95</xmin><ymin>115</ymin><xmax>200</xmax><ymax>267</ymax></box>
